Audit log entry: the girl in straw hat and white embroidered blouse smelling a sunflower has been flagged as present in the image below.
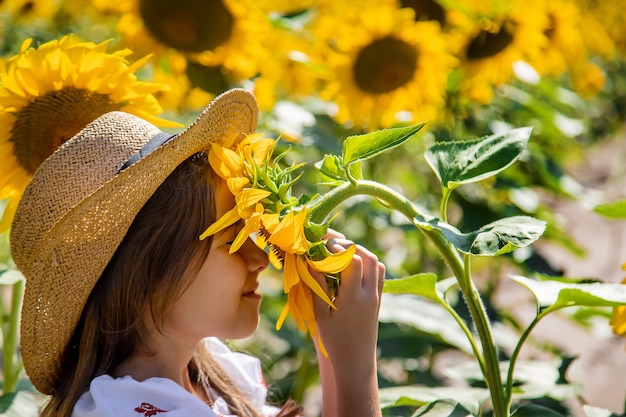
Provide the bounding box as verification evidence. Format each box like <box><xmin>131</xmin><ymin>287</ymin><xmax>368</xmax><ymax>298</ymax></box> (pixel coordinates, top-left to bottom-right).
<box><xmin>10</xmin><ymin>90</ymin><xmax>385</xmax><ymax>417</ymax></box>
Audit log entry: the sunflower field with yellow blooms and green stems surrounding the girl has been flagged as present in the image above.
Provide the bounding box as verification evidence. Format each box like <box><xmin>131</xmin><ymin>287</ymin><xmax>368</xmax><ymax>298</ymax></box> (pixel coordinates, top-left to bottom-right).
<box><xmin>0</xmin><ymin>0</ymin><xmax>626</xmax><ymax>417</ymax></box>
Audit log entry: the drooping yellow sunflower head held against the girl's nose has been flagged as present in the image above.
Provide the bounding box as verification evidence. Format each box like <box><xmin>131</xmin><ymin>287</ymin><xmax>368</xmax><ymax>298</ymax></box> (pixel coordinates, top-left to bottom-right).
<box><xmin>200</xmin><ymin>129</ymin><xmax>356</xmax><ymax>343</ymax></box>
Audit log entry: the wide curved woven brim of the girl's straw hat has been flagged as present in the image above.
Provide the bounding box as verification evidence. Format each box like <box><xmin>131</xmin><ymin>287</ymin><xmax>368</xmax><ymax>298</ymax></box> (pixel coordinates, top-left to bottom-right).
<box><xmin>11</xmin><ymin>89</ymin><xmax>258</xmax><ymax>394</ymax></box>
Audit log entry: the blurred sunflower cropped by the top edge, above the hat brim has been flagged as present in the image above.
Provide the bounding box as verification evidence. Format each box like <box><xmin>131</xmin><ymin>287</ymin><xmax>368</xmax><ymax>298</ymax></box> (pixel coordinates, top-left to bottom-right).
<box><xmin>112</xmin><ymin>0</ymin><xmax>269</xmax><ymax>80</ymax></box>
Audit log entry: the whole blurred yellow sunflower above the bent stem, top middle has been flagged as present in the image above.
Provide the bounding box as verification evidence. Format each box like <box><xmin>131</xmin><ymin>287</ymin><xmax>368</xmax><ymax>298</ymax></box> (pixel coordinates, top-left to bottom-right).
<box><xmin>315</xmin><ymin>4</ymin><xmax>456</xmax><ymax>130</ymax></box>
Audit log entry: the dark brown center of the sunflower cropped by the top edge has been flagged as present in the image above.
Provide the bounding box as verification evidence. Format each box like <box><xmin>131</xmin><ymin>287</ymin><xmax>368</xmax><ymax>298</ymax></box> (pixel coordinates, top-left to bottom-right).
<box><xmin>139</xmin><ymin>0</ymin><xmax>234</xmax><ymax>52</ymax></box>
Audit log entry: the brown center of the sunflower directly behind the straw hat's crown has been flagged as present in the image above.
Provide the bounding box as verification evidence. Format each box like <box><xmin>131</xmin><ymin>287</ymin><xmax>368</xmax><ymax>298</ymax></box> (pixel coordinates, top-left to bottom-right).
<box><xmin>10</xmin><ymin>87</ymin><xmax>119</xmax><ymax>174</ymax></box>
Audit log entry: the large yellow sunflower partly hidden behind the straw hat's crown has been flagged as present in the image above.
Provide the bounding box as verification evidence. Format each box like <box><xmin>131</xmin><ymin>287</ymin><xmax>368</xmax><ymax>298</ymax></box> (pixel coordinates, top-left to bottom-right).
<box><xmin>0</xmin><ymin>36</ymin><xmax>180</xmax><ymax>230</ymax></box>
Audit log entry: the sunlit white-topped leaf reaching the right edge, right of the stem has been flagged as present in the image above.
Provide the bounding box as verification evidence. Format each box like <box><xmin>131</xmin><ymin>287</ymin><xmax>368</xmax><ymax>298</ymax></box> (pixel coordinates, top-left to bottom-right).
<box><xmin>510</xmin><ymin>275</ymin><xmax>626</xmax><ymax>312</ymax></box>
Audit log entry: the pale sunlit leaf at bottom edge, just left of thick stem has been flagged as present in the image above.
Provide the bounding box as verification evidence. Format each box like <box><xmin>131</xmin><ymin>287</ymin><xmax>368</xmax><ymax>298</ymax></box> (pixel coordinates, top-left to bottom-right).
<box><xmin>378</xmin><ymin>385</ymin><xmax>490</xmax><ymax>415</ymax></box>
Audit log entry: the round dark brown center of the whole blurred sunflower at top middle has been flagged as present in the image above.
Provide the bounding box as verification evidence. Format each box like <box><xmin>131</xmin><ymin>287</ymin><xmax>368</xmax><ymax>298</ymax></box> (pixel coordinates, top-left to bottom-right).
<box><xmin>354</xmin><ymin>36</ymin><xmax>417</xmax><ymax>94</ymax></box>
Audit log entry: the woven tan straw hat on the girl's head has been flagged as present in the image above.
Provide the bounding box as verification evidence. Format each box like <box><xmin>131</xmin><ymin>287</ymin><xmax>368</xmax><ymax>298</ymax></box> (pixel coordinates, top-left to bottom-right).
<box><xmin>10</xmin><ymin>89</ymin><xmax>258</xmax><ymax>394</ymax></box>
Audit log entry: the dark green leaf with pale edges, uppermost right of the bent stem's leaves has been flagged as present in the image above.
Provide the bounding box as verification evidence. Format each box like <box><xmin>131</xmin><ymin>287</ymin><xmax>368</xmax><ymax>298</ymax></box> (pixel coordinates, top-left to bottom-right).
<box><xmin>425</xmin><ymin>127</ymin><xmax>531</xmax><ymax>189</ymax></box>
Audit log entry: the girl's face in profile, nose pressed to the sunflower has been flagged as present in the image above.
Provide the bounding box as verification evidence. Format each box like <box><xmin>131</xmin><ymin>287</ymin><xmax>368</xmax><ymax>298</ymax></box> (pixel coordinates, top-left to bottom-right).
<box><xmin>165</xmin><ymin>182</ymin><xmax>268</xmax><ymax>343</ymax></box>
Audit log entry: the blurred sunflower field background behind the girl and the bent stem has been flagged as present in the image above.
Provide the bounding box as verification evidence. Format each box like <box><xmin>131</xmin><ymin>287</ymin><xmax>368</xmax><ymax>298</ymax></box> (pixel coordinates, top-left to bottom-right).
<box><xmin>0</xmin><ymin>0</ymin><xmax>626</xmax><ymax>416</ymax></box>
